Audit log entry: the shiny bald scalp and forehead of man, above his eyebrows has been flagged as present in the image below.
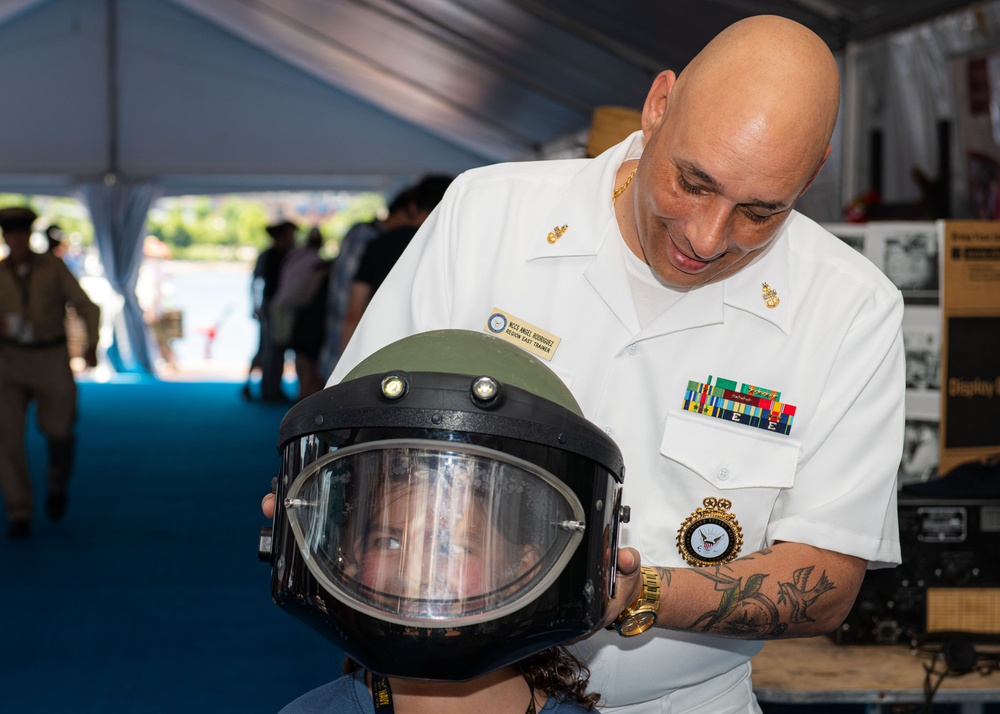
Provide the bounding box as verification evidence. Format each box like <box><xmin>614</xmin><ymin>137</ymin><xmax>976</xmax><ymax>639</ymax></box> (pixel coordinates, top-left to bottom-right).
<box><xmin>667</xmin><ymin>15</ymin><xmax>840</xmax><ymax>173</ymax></box>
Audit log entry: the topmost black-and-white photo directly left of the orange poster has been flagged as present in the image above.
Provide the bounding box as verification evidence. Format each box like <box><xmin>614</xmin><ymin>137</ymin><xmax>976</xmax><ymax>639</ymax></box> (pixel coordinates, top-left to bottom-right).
<box><xmin>865</xmin><ymin>221</ymin><xmax>941</xmax><ymax>305</ymax></box>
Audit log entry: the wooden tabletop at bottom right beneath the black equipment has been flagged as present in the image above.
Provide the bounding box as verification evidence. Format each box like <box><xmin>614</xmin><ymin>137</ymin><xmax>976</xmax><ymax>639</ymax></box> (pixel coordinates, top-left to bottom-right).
<box><xmin>752</xmin><ymin>637</ymin><xmax>1000</xmax><ymax>714</ymax></box>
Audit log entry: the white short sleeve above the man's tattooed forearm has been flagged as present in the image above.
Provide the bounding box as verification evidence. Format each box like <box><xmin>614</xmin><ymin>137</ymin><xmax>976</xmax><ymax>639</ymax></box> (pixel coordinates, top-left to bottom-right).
<box><xmin>767</xmin><ymin>291</ymin><xmax>905</xmax><ymax>568</ymax></box>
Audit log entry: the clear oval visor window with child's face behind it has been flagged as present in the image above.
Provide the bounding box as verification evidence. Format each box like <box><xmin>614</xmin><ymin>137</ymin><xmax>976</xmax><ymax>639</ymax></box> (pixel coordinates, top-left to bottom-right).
<box><xmin>285</xmin><ymin>440</ymin><xmax>585</xmax><ymax>628</ymax></box>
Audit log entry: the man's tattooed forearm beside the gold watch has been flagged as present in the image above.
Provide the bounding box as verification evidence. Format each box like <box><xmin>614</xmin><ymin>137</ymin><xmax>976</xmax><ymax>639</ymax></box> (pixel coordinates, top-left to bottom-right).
<box><xmin>657</xmin><ymin>543</ymin><xmax>867</xmax><ymax>640</ymax></box>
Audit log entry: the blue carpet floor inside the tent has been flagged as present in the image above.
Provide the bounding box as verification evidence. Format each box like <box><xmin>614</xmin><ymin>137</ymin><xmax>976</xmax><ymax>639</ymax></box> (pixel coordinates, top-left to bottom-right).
<box><xmin>0</xmin><ymin>380</ymin><xmax>341</xmax><ymax>714</ymax></box>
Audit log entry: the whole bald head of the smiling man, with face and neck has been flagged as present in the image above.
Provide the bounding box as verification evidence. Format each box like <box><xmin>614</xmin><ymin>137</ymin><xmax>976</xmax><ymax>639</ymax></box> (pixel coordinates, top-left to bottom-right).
<box><xmin>616</xmin><ymin>15</ymin><xmax>840</xmax><ymax>289</ymax></box>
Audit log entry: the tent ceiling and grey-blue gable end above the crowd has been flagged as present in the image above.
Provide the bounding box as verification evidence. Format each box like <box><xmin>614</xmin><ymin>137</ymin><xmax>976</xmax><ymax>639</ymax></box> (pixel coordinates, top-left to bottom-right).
<box><xmin>0</xmin><ymin>0</ymin><xmax>974</xmax><ymax>193</ymax></box>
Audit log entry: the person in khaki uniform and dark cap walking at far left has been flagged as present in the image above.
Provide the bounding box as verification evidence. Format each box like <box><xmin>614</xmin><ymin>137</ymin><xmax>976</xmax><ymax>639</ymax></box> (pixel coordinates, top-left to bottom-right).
<box><xmin>0</xmin><ymin>206</ymin><xmax>100</xmax><ymax>538</ymax></box>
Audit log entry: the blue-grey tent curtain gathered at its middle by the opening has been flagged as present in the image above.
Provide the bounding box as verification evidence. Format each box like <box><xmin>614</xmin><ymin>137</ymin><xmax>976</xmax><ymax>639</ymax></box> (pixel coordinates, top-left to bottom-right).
<box><xmin>78</xmin><ymin>177</ymin><xmax>160</xmax><ymax>373</ymax></box>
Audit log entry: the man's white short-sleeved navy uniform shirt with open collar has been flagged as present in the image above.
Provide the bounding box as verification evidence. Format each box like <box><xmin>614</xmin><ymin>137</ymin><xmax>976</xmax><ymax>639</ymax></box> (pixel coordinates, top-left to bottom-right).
<box><xmin>330</xmin><ymin>133</ymin><xmax>905</xmax><ymax>705</ymax></box>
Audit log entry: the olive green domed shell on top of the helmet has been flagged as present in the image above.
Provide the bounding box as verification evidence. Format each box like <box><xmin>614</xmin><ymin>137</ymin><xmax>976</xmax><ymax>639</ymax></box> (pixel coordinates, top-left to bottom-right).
<box><xmin>343</xmin><ymin>330</ymin><xmax>583</xmax><ymax>416</ymax></box>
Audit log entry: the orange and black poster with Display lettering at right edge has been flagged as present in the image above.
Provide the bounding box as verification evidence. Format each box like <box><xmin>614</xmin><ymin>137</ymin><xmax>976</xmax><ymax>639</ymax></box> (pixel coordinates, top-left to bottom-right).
<box><xmin>939</xmin><ymin>221</ymin><xmax>1000</xmax><ymax>475</ymax></box>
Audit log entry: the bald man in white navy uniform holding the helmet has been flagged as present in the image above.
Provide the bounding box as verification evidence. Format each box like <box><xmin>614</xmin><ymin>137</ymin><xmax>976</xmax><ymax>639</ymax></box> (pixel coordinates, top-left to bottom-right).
<box><xmin>265</xmin><ymin>16</ymin><xmax>904</xmax><ymax>714</ymax></box>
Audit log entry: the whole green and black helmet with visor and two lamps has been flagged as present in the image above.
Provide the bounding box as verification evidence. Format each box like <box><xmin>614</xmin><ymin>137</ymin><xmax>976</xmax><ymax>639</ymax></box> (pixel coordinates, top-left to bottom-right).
<box><xmin>262</xmin><ymin>330</ymin><xmax>627</xmax><ymax>680</ymax></box>
